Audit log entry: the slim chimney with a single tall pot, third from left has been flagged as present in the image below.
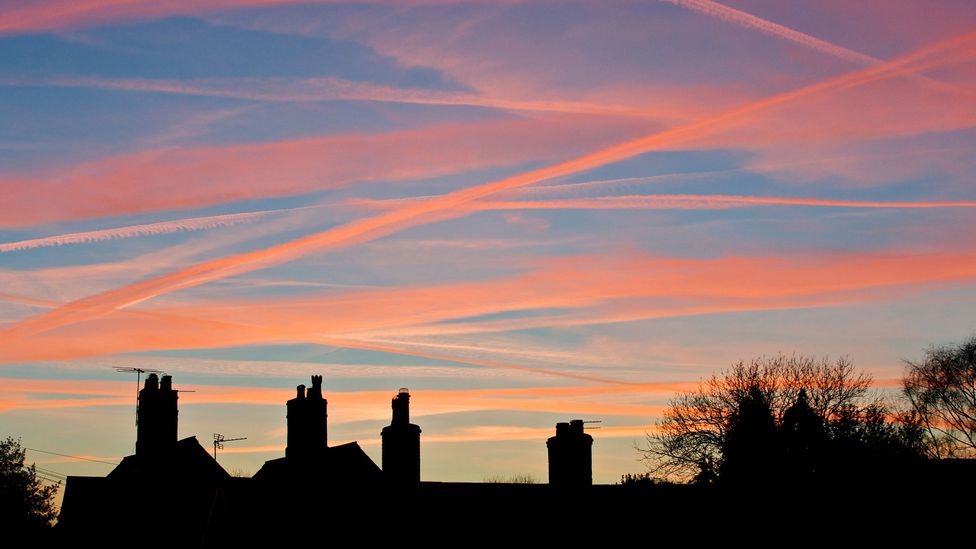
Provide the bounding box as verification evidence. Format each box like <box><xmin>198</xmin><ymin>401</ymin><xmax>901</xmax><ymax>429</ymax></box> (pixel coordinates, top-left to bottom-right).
<box><xmin>380</xmin><ymin>389</ymin><xmax>420</xmax><ymax>485</ymax></box>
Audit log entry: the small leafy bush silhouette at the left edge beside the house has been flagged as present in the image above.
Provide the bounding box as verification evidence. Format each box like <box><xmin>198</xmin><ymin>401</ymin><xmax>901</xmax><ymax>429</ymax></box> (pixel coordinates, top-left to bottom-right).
<box><xmin>0</xmin><ymin>436</ymin><xmax>60</xmax><ymax>535</ymax></box>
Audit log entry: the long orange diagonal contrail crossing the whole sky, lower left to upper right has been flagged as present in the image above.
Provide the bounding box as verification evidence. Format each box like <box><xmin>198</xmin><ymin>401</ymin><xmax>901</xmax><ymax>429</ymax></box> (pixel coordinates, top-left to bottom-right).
<box><xmin>0</xmin><ymin>28</ymin><xmax>976</xmax><ymax>343</ymax></box>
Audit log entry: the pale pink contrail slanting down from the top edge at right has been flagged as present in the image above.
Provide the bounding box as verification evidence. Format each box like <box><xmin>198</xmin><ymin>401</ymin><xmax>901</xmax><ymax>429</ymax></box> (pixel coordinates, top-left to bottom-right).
<box><xmin>661</xmin><ymin>0</ymin><xmax>883</xmax><ymax>65</ymax></box>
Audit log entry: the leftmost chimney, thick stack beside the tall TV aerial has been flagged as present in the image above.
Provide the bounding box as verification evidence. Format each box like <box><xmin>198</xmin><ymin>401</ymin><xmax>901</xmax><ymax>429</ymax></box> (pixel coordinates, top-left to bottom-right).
<box><xmin>136</xmin><ymin>374</ymin><xmax>179</xmax><ymax>458</ymax></box>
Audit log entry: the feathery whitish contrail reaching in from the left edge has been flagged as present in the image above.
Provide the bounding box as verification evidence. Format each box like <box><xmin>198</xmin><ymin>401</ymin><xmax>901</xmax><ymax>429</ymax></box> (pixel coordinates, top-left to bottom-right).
<box><xmin>0</xmin><ymin>206</ymin><xmax>316</xmax><ymax>253</ymax></box>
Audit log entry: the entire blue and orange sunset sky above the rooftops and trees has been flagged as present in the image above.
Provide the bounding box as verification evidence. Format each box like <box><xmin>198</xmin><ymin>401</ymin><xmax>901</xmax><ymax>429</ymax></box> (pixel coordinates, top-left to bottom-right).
<box><xmin>0</xmin><ymin>0</ymin><xmax>976</xmax><ymax>483</ymax></box>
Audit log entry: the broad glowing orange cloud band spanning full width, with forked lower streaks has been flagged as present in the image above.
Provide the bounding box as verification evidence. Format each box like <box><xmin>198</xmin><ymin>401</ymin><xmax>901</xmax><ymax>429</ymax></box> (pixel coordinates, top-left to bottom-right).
<box><xmin>0</xmin><ymin>252</ymin><xmax>976</xmax><ymax>370</ymax></box>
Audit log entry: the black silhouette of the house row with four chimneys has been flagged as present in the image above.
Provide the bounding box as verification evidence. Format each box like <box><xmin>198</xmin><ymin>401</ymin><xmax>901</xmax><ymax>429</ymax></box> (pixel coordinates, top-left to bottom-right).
<box><xmin>58</xmin><ymin>374</ymin><xmax>620</xmax><ymax>547</ymax></box>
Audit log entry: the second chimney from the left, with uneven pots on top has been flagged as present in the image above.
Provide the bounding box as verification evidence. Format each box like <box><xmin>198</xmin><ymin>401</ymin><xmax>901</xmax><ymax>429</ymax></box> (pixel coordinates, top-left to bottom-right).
<box><xmin>285</xmin><ymin>376</ymin><xmax>329</xmax><ymax>459</ymax></box>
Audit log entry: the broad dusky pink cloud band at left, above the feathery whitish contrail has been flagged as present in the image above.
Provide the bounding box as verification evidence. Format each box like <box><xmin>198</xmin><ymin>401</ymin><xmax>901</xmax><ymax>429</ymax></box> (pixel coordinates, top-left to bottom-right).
<box><xmin>0</xmin><ymin>115</ymin><xmax>637</xmax><ymax>227</ymax></box>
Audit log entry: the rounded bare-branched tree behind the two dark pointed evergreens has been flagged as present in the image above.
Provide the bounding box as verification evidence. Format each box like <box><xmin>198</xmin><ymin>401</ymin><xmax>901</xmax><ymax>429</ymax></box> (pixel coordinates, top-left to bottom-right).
<box><xmin>637</xmin><ymin>355</ymin><xmax>871</xmax><ymax>481</ymax></box>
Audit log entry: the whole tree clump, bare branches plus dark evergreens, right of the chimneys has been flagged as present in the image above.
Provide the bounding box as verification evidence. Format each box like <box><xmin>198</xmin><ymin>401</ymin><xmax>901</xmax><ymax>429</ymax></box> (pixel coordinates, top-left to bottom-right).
<box><xmin>638</xmin><ymin>355</ymin><xmax>918</xmax><ymax>482</ymax></box>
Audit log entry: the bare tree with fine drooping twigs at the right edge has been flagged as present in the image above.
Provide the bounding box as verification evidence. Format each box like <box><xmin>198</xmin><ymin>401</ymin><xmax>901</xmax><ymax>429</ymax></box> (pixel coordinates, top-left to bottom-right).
<box><xmin>903</xmin><ymin>335</ymin><xmax>976</xmax><ymax>458</ymax></box>
